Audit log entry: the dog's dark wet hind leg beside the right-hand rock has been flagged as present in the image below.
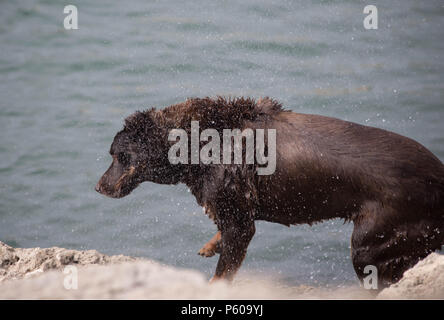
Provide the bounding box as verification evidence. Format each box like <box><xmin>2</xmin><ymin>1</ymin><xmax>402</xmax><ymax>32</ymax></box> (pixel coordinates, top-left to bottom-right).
<box><xmin>351</xmin><ymin>202</ymin><xmax>444</xmax><ymax>289</ymax></box>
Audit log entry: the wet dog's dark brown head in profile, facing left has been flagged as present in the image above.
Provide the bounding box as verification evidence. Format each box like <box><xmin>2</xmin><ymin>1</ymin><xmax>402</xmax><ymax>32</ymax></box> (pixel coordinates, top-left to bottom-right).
<box><xmin>95</xmin><ymin>110</ymin><xmax>178</xmax><ymax>198</ymax></box>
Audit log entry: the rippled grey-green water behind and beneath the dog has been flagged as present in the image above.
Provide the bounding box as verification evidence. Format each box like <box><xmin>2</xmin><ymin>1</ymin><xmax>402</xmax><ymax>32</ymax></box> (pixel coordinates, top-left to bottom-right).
<box><xmin>0</xmin><ymin>0</ymin><xmax>444</xmax><ymax>287</ymax></box>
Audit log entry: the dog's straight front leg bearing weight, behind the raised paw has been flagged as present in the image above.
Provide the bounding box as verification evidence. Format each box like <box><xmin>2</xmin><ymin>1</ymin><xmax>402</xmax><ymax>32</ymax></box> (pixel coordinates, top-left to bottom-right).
<box><xmin>211</xmin><ymin>220</ymin><xmax>256</xmax><ymax>281</ymax></box>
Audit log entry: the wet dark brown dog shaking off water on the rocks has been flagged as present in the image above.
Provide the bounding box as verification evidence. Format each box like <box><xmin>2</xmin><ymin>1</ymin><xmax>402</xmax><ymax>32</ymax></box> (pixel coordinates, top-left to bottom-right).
<box><xmin>96</xmin><ymin>98</ymin><xmax>444</xmax><ymax>286</ymax></box>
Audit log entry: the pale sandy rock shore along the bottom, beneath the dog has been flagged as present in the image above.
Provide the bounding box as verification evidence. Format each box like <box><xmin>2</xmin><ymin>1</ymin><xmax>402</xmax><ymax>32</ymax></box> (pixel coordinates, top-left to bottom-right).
<box><xmin>0</xmin><ymin>242</ymin><xmax>444</xmax><ymax>299</ymax></box>
